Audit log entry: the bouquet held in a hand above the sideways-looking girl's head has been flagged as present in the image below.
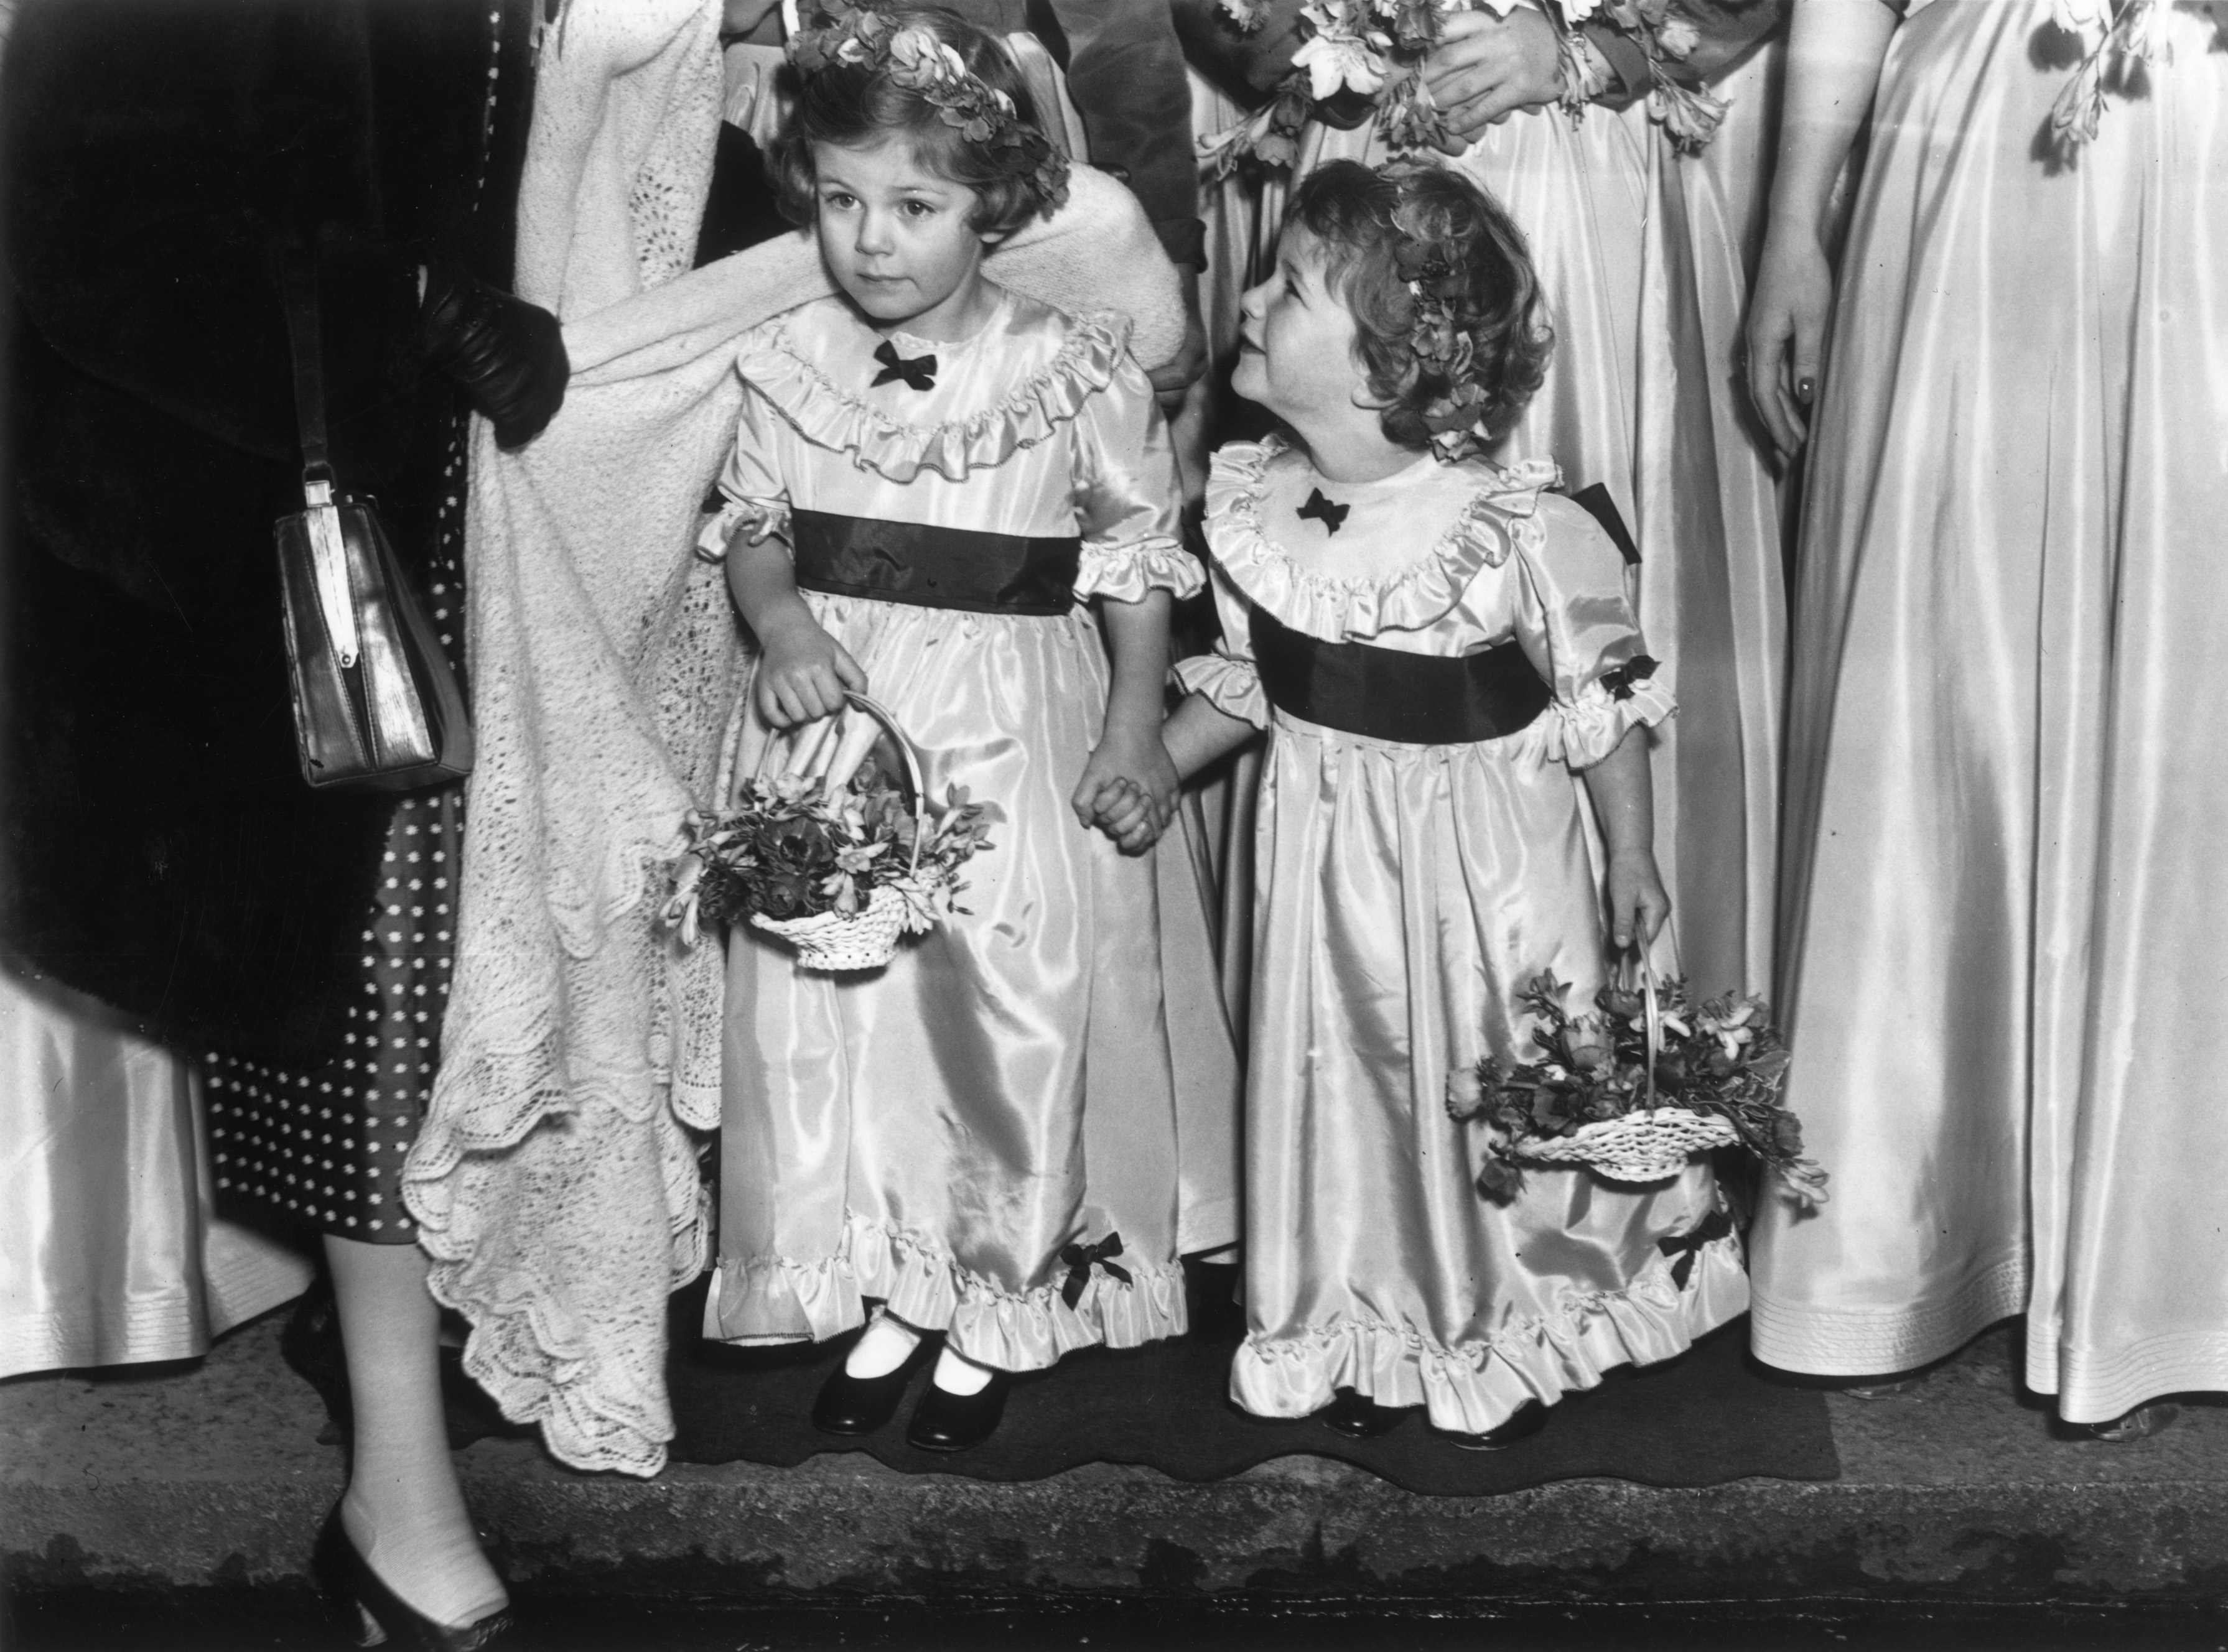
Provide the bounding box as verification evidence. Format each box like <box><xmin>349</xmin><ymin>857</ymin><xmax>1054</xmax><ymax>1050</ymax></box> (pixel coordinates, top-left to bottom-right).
<box><xmin>1199</xmin><ymin>0</ymin><xmax>1725</xmax><ymax>178</ymax></box>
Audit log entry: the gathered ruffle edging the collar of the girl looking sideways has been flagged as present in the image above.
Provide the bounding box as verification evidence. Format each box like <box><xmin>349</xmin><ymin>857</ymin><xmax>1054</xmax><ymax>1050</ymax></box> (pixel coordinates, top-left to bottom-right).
<box><xmin>1208</xmin><ymin>437</ymin><xmax>1562</xmax><ymax>643</ymax></box>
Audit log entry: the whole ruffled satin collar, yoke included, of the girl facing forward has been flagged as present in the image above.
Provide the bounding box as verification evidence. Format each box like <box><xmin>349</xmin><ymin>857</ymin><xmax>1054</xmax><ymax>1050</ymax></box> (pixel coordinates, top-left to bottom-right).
<box><xmin>735</xmin><ymin>292</ymin><xmax>1130</xmax><ymax>481</ymax></box>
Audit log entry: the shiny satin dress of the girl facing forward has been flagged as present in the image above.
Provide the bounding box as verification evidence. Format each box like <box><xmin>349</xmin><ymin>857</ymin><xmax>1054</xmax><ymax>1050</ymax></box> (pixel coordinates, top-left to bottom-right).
<box><xmin>706</xmin><ymin>294</ymin><xmax>1236</xmax><ymax>1369</ymax></box>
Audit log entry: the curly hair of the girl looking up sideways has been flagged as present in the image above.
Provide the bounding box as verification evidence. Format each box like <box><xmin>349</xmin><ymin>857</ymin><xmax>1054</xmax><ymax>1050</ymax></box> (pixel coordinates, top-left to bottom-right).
<box><xmin>1285</xmin><ymin>160</ymin><xmax>1555</xmax><ymax>447</ymax></box>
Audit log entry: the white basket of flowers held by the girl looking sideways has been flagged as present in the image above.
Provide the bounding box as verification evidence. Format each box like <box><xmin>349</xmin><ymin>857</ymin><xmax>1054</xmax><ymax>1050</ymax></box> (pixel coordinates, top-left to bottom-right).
<box><xmin>1446</xmin><ymin>971</ymin><xmax>1827</xmax><ymax>1209</ymax></box>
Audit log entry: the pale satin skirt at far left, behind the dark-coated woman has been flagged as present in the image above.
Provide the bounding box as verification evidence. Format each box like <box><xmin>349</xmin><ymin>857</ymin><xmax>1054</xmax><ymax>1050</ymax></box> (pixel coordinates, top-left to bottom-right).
<box><xmin>0</xmin><ymin>968</ymin><xmax>310</xmax><ymax>1376</ymax></box>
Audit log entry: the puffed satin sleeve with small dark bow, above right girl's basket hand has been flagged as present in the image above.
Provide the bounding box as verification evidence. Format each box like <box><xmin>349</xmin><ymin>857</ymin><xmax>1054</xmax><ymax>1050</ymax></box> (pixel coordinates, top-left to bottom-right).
<box><xmin>1515</xmin><ymin>494</ymin><xmax>1677</xmax><ymax>768</ymax></box>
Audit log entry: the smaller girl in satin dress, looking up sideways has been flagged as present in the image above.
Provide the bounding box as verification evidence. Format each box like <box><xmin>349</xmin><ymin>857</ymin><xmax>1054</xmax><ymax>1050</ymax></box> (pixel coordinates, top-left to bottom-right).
<box><xmin>1140</xmin><ymin>160</ymin><xmax>1747</xmax><ymax>1447</ymax></box>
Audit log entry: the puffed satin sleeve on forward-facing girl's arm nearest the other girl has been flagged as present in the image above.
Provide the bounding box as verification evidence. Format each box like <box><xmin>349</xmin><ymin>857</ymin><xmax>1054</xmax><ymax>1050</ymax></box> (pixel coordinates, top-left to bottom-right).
<box><xmin>1074</xmin><ymin>352</ymin><xmax>1203</xmax><ymax>603</ymax></box>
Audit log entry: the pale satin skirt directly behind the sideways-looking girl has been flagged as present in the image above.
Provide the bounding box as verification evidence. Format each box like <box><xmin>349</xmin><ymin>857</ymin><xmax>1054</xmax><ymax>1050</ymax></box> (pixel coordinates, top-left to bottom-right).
<box><xmin>1292</xmin><ymin>0</ymin><xmax>1784</xmax><ymax>1011</ymax></box>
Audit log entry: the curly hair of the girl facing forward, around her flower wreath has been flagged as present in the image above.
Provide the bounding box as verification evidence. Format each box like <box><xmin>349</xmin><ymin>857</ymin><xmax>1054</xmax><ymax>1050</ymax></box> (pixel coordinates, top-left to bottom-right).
<box><xmin>767</xmin><ymin>4</ymin><xmax>1043</xmax><ymax>241</ymax></box>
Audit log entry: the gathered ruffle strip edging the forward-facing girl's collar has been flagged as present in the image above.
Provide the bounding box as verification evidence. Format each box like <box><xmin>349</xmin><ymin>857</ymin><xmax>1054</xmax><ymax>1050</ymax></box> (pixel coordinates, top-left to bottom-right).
<box><xmin>735</xmin><ymin>316</ymin><xmax>1130</xmax><ymax>481</ymax></box>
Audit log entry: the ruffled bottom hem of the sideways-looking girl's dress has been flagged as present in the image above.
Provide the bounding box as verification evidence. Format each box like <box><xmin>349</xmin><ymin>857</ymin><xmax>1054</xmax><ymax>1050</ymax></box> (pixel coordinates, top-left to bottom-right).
<box><xmin>1230</xmin><ymin>1236</ymin><xmax>1749</xmax><ymax>1434</ymax></box>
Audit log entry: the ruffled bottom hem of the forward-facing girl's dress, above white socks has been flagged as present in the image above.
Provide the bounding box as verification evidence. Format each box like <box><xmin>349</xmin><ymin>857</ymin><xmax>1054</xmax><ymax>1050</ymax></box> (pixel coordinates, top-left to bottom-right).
<box><xmin>704</xmin><ymin>1215</ymin><xmax>1188</xmax><ymax>1371</ymax></box>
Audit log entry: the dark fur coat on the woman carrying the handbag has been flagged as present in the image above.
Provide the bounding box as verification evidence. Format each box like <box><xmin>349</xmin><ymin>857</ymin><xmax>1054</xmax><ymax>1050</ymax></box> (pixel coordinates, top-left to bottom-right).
<box><xmin>0</xmin><ymin>0</ymin><xmax>533</xmax><ymax>1062</ymax></box>
